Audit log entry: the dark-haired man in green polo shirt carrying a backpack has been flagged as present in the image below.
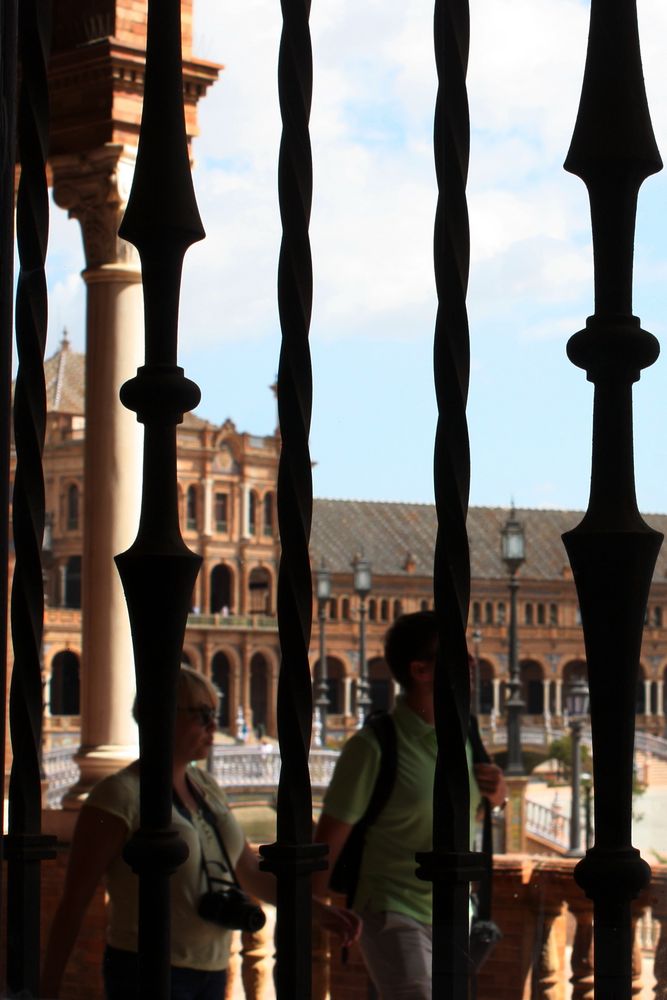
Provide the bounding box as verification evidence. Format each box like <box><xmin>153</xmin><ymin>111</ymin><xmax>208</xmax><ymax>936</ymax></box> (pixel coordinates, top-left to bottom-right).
<box><xmin>313</xmin><ymin>611</ymin><xmax>505</xmax><ymax>1000</ymax></box>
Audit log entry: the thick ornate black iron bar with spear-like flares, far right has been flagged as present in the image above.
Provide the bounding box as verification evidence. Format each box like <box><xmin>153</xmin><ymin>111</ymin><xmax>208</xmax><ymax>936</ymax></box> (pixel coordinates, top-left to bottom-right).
<box><xmin>563</xmin><ymin>0</ymin><xmax>662</xmax><ymax>1000</ymax></box>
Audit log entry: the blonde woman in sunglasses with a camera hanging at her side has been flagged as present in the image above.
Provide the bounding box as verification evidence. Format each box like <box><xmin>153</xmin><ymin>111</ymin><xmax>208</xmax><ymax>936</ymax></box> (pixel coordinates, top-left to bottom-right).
<box><xmin>42</xmin><ymin>666</ymin><xmax>360</xmax><ymax>1000</ymax></box>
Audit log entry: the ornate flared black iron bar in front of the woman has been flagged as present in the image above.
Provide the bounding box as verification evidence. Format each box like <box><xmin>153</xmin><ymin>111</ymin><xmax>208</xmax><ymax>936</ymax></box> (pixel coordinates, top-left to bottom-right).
<box><xmin>116</xmin><ymin>0</ymin><xmax>204</xmax><ymax>1000</ymax></box>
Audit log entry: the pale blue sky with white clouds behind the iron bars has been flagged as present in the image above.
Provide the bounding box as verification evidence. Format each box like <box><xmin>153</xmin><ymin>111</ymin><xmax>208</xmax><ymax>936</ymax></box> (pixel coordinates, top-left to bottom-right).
<box><xmin>43</xmin><ymin>0</ymin><xmax>667</xmax><ymax>512</ymax></box>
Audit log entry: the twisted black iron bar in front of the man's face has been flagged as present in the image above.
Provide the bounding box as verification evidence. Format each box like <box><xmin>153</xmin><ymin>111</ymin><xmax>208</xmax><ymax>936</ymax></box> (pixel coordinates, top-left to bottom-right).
<box><xmin>418</xmin><ymin>0</ymin><xmax>481</xmax><ymax>1000</ymax></box>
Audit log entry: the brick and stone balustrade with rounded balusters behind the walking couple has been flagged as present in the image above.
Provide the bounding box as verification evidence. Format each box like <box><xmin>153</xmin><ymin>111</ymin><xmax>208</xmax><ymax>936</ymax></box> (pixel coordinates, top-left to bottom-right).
<box><xmin>223</xmin><ymin>855</ymin><xmax>667</xmax><ymax>1000</ymax></box>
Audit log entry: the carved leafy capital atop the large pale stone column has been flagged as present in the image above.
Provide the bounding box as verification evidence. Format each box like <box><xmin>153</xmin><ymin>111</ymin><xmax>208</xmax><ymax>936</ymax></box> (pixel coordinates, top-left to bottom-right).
<box><xmin>51</xmin><ymin>143</ymin><xmax>139</xmax><ymax>270</ymax></box>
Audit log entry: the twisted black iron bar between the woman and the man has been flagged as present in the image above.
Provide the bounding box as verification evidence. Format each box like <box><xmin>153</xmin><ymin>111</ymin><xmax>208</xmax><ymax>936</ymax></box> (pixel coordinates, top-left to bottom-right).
<box><xmin>260</xmin><ymin>0</ymin><xmax>327</xmax><ymax>1000</ymax></box>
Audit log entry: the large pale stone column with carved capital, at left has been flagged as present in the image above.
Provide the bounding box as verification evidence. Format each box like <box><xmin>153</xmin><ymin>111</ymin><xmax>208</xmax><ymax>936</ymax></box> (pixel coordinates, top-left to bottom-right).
<box><xmin>52</xmin><ymin>143</ymin><xmax>143</xmax><ymax>806</ymax></box>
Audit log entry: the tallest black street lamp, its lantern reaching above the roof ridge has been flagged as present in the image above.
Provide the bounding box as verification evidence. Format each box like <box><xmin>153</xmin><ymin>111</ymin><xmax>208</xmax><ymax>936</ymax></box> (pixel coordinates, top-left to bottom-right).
<box><xmin>500</xmin><ymin>504</ymin><xmax>526</xmax><ymax>777</ymax></box>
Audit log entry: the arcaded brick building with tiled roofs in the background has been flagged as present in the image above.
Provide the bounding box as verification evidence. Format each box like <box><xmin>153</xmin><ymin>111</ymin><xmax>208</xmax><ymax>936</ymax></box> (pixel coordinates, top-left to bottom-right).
<box><xmin>28</xmin><ymin>337</ymin><xmax>667</xmax><ymax>752</ymax></box>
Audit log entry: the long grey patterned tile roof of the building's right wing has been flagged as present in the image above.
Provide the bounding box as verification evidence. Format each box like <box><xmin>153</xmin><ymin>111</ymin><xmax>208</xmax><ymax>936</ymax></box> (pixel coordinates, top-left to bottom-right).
<box><xmin>310</xmin><ymin>500</ymin><xmax>667</xmax><ymax>580</ymax></box>
